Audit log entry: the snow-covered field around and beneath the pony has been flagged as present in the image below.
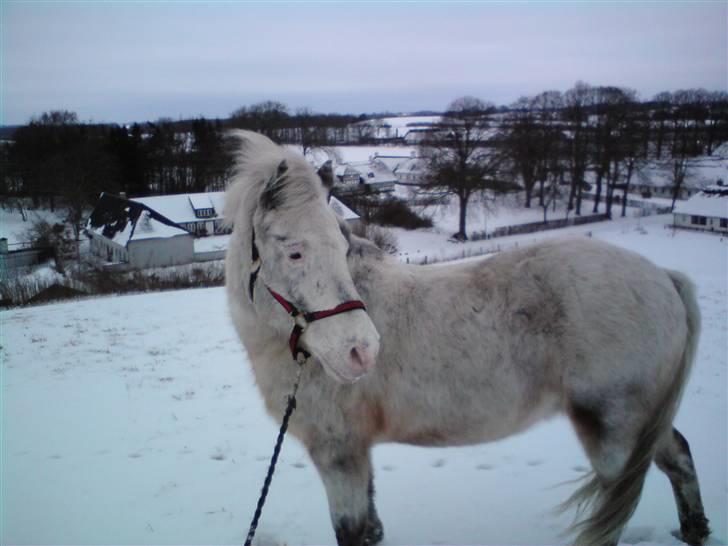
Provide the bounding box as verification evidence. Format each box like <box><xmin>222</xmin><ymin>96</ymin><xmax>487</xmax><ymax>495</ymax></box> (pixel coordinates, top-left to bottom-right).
<box><xmin>0</xmin><ymin>216</ymin><xmax>728</xmax><ymax>545</ymax></box>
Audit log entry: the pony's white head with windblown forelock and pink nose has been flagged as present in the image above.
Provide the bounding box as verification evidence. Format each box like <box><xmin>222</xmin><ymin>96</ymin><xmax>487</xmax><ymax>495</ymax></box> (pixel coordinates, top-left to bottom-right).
<box><xmin>225</xmin><ymin>131</ymin><xmax>379</xmax><ymax>382</ymax></box>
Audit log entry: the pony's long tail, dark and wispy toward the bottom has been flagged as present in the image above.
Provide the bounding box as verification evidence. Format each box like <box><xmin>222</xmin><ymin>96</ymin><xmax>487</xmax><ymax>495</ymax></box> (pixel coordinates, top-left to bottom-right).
<box><xmin>559</xmin><ymin>271</ymin><xmax>700</xmax><ymax>546</ymax></box>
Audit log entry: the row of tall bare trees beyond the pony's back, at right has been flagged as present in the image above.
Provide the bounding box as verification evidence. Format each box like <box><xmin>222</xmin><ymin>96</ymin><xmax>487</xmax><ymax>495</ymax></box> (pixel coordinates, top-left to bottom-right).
<box><xmin>420</xmin><ymin>82</ymin><xmax>728</xmax><ymax>239</ymax></box>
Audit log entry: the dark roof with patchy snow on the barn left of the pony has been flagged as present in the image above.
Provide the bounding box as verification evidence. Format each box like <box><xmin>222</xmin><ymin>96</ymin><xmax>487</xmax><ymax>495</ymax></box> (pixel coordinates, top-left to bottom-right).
<box><xmin>86</xmin><ymin>193</ymin><xmax>189</xmax><ymax>246</ymax></box>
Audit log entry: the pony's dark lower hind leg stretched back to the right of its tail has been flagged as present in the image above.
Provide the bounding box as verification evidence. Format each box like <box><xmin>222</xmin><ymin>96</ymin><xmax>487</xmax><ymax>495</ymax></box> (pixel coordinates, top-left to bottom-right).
<box><xmin>655</xmin><ymin>428</ymin><xmax>710</xmax><ymax>546</ymax></box>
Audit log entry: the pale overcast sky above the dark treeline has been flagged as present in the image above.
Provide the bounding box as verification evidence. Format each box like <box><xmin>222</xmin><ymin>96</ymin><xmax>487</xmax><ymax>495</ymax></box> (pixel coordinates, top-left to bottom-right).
<box><xmin>0</xmin><ymin>0</ymin><xmax>728</xmax><ymax>124</ymax></box>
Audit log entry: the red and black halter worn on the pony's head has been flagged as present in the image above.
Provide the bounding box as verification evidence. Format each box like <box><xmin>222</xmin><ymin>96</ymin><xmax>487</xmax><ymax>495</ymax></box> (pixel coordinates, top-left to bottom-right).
<box><xmin>248</xmin><ymin>230</ymin><xmax>366</xmax><ymax>364</ymax></box>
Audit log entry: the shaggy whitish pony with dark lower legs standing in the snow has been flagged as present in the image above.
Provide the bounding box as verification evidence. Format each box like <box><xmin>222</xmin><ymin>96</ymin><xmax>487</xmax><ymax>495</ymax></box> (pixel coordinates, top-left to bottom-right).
<box><xmin>225</xmin><ymin>132</ymin><xmax>710</xmax><ymax>546</ymax></box>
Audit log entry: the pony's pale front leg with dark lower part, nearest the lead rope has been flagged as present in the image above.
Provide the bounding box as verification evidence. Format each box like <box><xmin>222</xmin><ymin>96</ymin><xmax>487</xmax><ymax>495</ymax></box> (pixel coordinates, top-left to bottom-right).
<box><xmin>309</xmin><ymin>441</ymin><xmax>382</xmax><ymax>546</ymax></box>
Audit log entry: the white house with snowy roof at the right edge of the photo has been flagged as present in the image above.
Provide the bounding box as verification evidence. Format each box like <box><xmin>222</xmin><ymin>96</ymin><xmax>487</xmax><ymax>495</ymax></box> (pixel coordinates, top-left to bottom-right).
<box><xmin>672</xmin><ymin>185</ymin><xmax>728</xmax><ymax>233</ymax></box>
